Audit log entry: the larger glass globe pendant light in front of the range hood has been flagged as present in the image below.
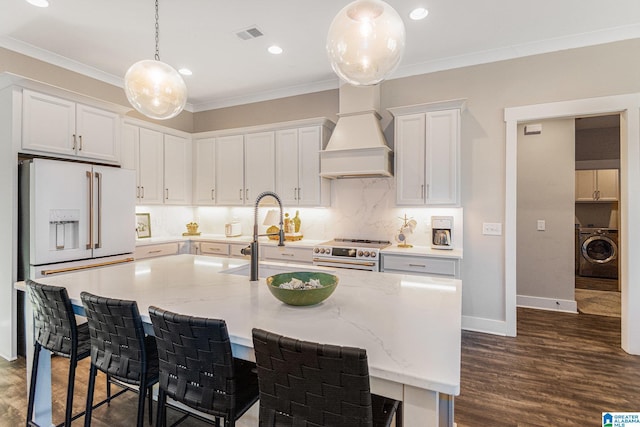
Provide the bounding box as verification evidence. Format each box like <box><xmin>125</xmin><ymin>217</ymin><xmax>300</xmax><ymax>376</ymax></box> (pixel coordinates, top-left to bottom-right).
<box><xmin>327</xmin><ymin>0</ymin><xmax>405</xmax><ymax>86</ymax></box>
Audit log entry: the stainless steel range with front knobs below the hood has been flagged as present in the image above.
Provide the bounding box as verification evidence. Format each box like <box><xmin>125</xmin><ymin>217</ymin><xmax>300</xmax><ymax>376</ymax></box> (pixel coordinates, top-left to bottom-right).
<box><xmin>313</xmin><ymin>238</ymin><xmax>391</xmax><ymax>271</ymax></box>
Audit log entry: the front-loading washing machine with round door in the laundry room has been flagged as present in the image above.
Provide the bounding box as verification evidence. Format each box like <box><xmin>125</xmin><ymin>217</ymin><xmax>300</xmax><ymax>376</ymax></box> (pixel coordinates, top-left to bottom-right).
<box><xmin>578</xmin><ymin>228</ymin><xmax>618</xmax><ymax>279</ymax></box>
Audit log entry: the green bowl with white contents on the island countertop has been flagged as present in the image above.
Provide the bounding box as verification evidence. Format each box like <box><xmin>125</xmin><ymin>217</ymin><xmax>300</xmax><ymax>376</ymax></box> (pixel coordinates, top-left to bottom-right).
<box><xmin>267</xmin><ymin>271</ymin><xmax>338</xmax><ymax>305</ymax></box>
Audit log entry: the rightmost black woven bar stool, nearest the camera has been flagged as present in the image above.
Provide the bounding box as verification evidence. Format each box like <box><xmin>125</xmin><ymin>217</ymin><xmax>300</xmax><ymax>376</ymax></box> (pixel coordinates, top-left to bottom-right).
<box><xmin>253</xmin><ymin>329</ymin><xmax>401</xmax><ymax>427</ymax></box>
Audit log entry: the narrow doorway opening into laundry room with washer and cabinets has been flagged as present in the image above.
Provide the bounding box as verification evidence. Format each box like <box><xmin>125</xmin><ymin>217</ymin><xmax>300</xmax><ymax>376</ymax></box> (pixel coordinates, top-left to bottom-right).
<box><xmin>574</xmin><ymin>114</ymin><xmax>623</xmax><ymax>317</ymax></box>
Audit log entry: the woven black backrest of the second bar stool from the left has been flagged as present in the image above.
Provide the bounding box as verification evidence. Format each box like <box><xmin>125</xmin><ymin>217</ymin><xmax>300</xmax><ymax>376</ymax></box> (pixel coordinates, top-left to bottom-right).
<box><xmin>80</xmin><ymin>292</ymin><xmax>149</xmax><ymax>385</ymax></box>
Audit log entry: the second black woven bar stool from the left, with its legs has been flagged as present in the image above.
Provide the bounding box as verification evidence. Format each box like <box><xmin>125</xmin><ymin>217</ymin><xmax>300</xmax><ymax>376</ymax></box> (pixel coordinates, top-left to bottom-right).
<box><xmin>80</xmin><ymin>292</ymin><xmax>158</xmax><ymax>427</ymax></box>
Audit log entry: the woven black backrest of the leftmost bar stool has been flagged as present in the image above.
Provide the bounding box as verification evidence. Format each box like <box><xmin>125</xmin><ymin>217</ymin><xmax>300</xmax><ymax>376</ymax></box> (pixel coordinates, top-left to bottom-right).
<box><xmin>26</xmin><ymin>280</ymin><xmax>78</xmax><ymax>358</ymax></box>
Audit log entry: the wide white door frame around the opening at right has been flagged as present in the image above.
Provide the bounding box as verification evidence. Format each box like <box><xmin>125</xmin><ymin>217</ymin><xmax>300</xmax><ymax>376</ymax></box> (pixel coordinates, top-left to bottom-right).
<box><xmin>504</xmin><ymin>93</ymin><xmax>640</xmax><ymax>354</ymax></box>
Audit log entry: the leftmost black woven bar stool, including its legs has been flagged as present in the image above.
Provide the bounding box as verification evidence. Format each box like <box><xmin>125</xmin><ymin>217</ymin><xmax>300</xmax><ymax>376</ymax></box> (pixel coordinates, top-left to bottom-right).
<box><xmin>26</xmin><ymin>280</ymin><xmax>90</xmax><ymax>426</ymax></box>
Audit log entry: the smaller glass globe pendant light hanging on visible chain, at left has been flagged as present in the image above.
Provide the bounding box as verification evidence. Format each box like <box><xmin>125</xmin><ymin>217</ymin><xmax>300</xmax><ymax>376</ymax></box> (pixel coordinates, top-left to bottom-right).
<box><xmin>124</xmin><ymin>0</ymin><xmax>187</xmax><ymax>120</ymax></box>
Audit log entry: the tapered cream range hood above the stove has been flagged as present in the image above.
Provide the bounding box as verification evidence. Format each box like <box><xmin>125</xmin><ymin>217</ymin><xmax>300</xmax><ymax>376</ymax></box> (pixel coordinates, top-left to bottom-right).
<box><xmin>320</xmin><ymin>84</ymin><xmax>393</xmax><ymax>179</ymax></box>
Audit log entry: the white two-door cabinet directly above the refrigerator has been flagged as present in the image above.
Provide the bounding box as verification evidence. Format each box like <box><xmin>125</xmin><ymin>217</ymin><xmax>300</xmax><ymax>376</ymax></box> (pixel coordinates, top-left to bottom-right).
<box><xmin>22</xmin><ymin>89</ymin><xmax>120</xmax><ymax>163</ymax></box>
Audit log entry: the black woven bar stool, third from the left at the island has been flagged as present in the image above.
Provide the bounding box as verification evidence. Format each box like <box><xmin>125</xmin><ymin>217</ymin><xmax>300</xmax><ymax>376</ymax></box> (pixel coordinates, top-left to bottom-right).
<box><xmin>149</xmin><ymin>307</ymin><xmax>258</xmax><ymax>427</ymax></box>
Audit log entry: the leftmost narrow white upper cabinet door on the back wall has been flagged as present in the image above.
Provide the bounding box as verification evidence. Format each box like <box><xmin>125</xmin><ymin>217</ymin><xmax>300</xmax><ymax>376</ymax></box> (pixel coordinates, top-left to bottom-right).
<box><xmin>193</xmin><ymin>138</ymin><xmax>216</xmax><ymax>206</ymax></box>
